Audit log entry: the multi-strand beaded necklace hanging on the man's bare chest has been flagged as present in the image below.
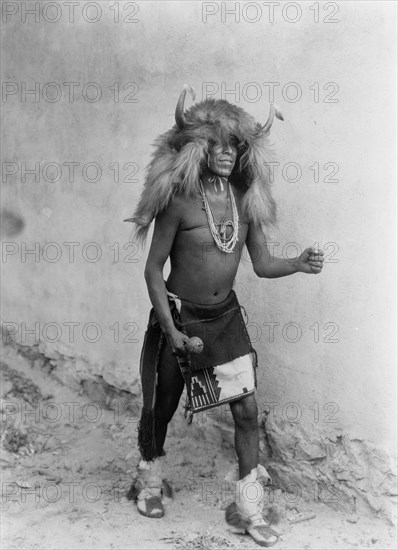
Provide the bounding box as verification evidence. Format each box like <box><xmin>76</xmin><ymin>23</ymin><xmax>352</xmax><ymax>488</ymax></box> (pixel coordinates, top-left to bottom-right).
<box><xmin>199</xmin><ymin>180</ymin><xmax>239</xmax><ymax>254</ymax></box>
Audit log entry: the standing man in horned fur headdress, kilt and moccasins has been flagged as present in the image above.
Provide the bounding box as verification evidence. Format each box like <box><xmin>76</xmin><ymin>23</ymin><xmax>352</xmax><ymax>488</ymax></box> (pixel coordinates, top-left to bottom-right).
<box><xmin>124</xmin><ymin>89</ymin><xmax>323</xmax><ymax>546</ymax></box>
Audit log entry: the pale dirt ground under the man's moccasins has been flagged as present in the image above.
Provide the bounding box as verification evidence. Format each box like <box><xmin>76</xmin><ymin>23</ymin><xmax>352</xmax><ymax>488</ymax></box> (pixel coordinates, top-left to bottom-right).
<box><xmin>1</xmin><ymin>349</ymin><xmax>397</xmax><ymax>550</ymax></box>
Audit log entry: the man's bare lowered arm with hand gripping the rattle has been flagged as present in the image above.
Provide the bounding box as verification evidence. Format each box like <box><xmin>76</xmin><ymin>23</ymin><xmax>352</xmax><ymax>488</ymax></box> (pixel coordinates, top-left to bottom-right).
<box><xmin>145</xmin><ymin>201</ymin><xmax>188</xmax><ymax>355</ymax></box>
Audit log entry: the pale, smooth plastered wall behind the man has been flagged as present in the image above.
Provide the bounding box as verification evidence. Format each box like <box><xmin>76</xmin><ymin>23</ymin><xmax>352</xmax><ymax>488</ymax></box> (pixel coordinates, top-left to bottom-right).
<box><xmin>2</xmin><ymin>1</ymin><xmax>396</xmax><ymax>524</ymax></box>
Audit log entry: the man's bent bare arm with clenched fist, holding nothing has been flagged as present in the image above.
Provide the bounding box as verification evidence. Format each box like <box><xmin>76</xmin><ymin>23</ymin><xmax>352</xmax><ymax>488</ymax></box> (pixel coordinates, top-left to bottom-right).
<box><xmin>246</xmin><ymin>223</ymin><xmax>324</xmax><ymax>279</ymax></box>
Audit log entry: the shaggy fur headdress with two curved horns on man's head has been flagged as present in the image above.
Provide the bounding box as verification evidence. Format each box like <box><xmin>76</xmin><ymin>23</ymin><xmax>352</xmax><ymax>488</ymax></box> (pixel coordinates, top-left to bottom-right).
<box><xmin>125</xmin><ymin>86</ymin><xmax>283</xmax><ymax>241</ymax></box>
